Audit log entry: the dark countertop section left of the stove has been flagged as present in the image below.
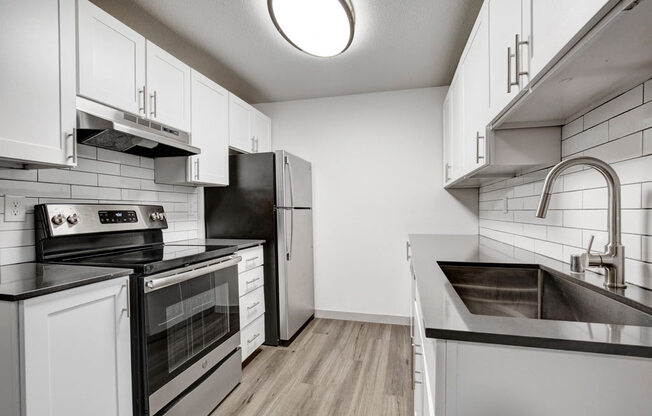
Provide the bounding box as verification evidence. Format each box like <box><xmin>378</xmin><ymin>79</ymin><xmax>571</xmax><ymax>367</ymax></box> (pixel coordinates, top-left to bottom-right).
<box><xmin>0</xmin><ymin>263</ymin><xmax>133</xmax><ymax>301</ymax></box>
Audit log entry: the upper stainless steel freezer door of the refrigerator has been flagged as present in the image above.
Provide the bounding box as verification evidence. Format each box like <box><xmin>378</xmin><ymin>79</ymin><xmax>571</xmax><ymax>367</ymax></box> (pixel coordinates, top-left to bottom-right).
<box><xmin>276</xmin><ymin>150</ymin><xmax>312</xmax><ymax>208</ymax></box>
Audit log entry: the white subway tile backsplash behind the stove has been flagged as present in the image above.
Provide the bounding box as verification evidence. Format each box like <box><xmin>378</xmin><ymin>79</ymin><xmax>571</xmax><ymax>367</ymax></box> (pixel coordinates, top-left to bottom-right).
<box><xmin>0</xmin><ymin>152</ymin><xmax>200</xmax><ymax>265</ymax></box>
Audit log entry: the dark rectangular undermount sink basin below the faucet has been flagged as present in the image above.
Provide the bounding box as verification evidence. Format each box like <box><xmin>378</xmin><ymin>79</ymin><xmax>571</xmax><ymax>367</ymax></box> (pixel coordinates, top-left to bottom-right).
<box><xmin>440</xmin><ymin>263</ymin><xmax>652</xmax><ymax>326</ymax></box>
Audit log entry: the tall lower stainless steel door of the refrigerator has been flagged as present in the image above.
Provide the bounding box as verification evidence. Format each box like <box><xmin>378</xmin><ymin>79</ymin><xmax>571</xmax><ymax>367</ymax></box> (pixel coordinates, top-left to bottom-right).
<box><xmin>277</xmin><ymin>209</ymin><xmax>315</xmax><ymax>341</ymax></box>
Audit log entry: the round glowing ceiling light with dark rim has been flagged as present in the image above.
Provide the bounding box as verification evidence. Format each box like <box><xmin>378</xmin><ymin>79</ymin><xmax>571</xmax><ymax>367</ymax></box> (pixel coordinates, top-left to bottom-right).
<box><xmin>267</xmin><ymin>0</ymin><xmax>355</xmax><ymax>57</ymax></box>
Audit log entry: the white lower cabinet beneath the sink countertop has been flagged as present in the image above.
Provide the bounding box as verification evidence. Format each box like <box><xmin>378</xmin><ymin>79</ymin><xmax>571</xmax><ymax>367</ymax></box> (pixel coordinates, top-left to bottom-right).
<box><xmin>412</xmin><ymin>268</ymin><xmax>652</xmax><ymax>416</ymax></box>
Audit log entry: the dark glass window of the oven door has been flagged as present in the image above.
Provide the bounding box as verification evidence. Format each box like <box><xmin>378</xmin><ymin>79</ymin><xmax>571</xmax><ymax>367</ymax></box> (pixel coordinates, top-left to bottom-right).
<box><xmin>146</xmin><ymin>268</ymin><xmax>240</xmax><ymax>394</ymax></box>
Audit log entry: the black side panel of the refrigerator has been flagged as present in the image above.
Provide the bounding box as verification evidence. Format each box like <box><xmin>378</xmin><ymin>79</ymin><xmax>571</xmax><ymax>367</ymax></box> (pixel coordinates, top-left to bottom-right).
<box><xmin>204</xmin><ymin>153</ymin><xmax>280</xmax><ymax>345</ymax></box>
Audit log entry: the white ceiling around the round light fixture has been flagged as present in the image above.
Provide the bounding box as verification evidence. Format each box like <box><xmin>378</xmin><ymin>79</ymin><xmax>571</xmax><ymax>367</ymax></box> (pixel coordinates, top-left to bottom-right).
<box><xmin>116</xmin><ymin>0</ymin><xmax>482</xmax><ymax>103</ymax></box>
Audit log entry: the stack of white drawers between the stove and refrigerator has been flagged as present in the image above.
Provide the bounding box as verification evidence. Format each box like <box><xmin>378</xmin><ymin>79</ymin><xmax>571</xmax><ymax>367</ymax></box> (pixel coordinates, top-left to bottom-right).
<box><xmin>236</xmin><ymin>246</ymin><xmax>265</xmax><ymax>361</ymax></box>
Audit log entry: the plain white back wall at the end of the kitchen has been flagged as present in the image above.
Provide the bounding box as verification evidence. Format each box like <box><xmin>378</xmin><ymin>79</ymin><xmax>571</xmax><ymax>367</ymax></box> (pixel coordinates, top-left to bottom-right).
<box><xmin>257</xmin><ymin>87</ymin><xmax>478</xmax><ymax>321</ymax></box>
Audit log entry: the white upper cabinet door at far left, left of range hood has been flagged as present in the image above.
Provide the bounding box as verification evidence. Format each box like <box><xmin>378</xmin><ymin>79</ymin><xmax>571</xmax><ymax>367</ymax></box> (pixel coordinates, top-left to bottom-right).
<box><xmin>0</xmin><ymin>0</ymin><xmax>77</xmax><ymax>166</ymax></box>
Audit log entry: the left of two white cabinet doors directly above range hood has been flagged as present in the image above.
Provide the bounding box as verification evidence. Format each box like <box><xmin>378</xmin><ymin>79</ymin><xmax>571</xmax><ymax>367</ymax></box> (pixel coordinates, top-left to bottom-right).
<box><xmin>77</xmin><ymin>0</ymin><xmax>145</xmax><ymax>115</ymax></box>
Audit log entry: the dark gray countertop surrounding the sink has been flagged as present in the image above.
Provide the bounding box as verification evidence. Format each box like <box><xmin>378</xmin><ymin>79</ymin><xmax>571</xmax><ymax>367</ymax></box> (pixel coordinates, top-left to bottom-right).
<box><xmin>409</xmin><ymin>234</ymin><xmax>652</xmax><ymax>357</ymax></box>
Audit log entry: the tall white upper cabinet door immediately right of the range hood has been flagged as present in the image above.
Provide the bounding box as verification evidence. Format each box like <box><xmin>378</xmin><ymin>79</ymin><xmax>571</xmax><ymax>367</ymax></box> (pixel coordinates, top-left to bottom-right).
<box><xmin>189</xmin><ymin>70</ymin><xmax>229</xmax><ymax>185</ymax></box>
